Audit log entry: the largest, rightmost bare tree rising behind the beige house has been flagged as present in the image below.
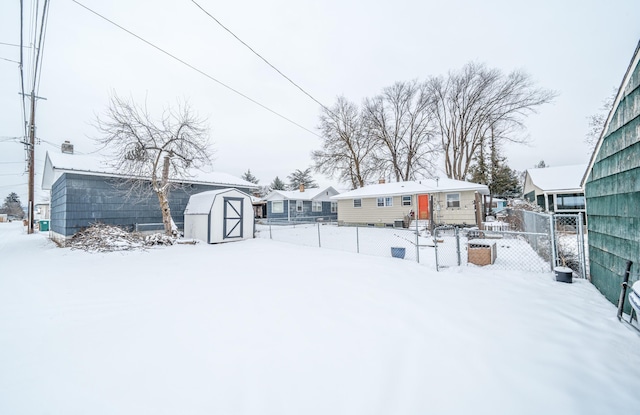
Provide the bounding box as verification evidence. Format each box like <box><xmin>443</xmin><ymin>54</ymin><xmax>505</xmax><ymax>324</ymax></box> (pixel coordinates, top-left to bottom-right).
<box><xmin>427</xmin><ymin>63</ymin><xmax>556</xmax><ymax>180</ymax></box>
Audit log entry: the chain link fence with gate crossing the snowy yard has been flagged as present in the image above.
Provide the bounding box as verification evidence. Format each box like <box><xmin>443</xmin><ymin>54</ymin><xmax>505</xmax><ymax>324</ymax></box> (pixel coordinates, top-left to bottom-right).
<box><xmin>256</xmin><ymin>210</ymin><xmax>587</xmax><ymax>278</ymax></box>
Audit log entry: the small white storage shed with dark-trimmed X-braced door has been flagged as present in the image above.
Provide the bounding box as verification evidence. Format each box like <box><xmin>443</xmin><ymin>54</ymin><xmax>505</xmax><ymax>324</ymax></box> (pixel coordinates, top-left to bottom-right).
<box><xmin>184</xmin><ymin>188</ymin><xmax>254</xmax><ymax>244</ymax></box>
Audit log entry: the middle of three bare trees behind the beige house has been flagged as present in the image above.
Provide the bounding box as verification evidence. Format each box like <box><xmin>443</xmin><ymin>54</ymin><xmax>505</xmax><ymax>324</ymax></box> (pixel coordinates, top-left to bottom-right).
<box><xmin>365</xmin><ymin>81</ymin><xmax>439</xmax><ymax>181</ymax></box>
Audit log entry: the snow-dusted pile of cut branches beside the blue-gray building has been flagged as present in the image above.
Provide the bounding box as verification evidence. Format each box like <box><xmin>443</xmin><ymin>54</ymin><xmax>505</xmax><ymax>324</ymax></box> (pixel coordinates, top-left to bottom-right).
<box><xmin>67</xmin><ymin>223</ymin><xmax>175</xmax><ymax>252</ymax></box>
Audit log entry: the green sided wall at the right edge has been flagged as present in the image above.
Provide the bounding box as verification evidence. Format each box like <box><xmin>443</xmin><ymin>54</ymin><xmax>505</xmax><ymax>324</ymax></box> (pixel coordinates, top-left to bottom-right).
<box><xmin>585</xmin><ymin>57</ymin><xmax>640</xmax><ymax>304</ymax></box>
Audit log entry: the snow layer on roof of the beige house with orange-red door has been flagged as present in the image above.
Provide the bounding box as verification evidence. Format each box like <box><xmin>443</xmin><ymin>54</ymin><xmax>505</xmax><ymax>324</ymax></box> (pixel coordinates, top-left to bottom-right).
<box><xmin>332</xmin><ymin>178</ymin><xmax>489</xmax><ymax>200</ymax></box>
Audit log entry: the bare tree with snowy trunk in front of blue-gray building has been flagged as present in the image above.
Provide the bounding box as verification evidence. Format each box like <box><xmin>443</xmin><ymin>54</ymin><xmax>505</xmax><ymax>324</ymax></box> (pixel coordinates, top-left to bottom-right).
<box><xmin>96</xmin><ymin>94</ymin><xmax>211</xmax><ymax>234</ymax></box>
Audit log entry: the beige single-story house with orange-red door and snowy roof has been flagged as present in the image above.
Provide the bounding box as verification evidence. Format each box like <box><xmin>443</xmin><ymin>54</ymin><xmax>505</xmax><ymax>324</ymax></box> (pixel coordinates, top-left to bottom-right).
<box><xmin>331</xmin><ymin>178</ymin><xmax>489</xmax><ymax>227</ymax></box>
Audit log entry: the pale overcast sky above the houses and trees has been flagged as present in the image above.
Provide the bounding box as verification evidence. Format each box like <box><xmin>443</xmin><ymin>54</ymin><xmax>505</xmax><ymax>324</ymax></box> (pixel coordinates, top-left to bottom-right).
<box><xmin>0</xmin><ymin>0</ymin><xmax>640</xmax><ymax>204</ymax></box>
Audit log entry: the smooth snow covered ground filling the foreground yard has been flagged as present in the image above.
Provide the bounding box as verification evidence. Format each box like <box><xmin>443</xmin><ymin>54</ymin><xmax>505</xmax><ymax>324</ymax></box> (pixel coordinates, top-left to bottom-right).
<box><xmin>0</xmin><ymin>223</ymin><xmax>640</xmax><ymax>415</ymax></box>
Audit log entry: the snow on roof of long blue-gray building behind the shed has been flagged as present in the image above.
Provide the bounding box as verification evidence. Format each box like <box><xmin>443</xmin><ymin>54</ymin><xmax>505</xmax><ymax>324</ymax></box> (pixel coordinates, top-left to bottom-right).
<box><xmin>43</xmin><ymin>152</ymin><xmax>259</xmax><ymax>189</ymax></box>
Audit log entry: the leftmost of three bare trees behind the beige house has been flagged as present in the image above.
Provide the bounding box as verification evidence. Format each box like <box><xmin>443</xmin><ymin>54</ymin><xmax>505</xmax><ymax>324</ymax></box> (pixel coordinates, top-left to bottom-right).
<box><xmin>311</xmin><ymin>96</ymin><xmax>375</xmax><ymax>189</ymax></box>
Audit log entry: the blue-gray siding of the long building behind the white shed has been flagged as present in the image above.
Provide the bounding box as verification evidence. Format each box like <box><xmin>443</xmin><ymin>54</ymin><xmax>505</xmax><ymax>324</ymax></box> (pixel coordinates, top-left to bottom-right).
<box><xmin>50</xmin><ymin>173</ymin><xmax>250</xmax><ymax>237</ymax></box>
